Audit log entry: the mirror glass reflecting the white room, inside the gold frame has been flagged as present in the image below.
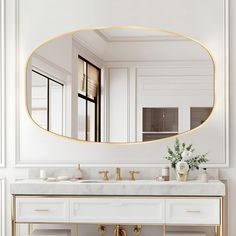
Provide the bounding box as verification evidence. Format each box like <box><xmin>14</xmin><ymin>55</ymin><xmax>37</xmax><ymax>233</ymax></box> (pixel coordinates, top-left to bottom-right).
<box><xmin>26</xmin><ymin>28</ymin><xmax>214</xmax><ymax>142</ymax></box>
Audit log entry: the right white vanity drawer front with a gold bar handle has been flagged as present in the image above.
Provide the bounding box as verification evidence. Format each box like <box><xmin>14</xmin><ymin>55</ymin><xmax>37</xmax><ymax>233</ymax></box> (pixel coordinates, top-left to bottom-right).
<box><xmin>166</xmin><ymin>199</ymin><xmax>220</xmax><ymax>225</ymax></box>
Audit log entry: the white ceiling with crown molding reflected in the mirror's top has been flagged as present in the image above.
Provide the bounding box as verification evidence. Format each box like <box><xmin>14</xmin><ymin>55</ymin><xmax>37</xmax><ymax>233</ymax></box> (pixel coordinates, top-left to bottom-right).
<box><xmin>73</xmin><ymin>28</ymin><xmax>210</xmax><ymax>61</ymax></box>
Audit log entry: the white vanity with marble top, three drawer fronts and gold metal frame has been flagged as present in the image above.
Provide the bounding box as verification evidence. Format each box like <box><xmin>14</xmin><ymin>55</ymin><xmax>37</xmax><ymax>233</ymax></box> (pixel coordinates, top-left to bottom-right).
<box><xmin>11</xmin><ymin>180</ymin><xmax>225</xmax><ymax>236</ymax></box>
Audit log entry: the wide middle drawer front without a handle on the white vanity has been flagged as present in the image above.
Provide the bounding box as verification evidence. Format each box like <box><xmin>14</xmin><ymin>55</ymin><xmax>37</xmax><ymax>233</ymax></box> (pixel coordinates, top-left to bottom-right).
<box><xmin>70</xmin><ymin>198</ymin><xmax>165</xmax><ymax>224</ymax></box>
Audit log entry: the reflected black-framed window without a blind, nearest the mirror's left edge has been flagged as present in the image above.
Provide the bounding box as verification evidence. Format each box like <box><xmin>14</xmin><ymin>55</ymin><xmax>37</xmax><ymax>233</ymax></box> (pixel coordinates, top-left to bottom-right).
<box><xmin>31</xmin><ymin>69</ymin><xmax>64</xmax><ymax>135</ymax></box>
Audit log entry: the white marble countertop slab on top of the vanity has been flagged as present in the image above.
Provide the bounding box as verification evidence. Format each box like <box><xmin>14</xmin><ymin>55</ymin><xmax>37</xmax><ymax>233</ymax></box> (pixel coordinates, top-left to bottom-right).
<box><xmin>10</xmin><ymin>179</ymin><xmax>225</xmax><ymax>196</ymax></box>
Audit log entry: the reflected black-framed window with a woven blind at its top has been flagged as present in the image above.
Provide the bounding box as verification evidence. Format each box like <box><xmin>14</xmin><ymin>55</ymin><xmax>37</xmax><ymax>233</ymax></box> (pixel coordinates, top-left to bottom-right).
<box><xmin>78</xmin><ymin>56</ymin><xmax>101</xmax><ymax>142</ymax></box>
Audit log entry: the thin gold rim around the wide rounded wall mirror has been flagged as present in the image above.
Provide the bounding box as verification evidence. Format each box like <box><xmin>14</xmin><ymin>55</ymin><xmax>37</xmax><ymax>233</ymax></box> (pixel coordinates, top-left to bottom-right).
<box><xmin>25</xmin><ymin>26</ymin><xmax>216</xmax><ymax>145</ymax></box>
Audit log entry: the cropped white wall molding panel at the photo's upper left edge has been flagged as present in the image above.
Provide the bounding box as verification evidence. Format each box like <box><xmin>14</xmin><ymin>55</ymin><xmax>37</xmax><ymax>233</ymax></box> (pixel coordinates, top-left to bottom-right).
<box><xmin>0</xmin><ymin>0</ymin><xmax>6</xmax><ymax>167</ymax></box>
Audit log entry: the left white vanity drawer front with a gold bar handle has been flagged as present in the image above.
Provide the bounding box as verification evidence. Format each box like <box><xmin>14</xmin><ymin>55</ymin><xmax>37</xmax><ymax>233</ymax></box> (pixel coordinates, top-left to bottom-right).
<box><xmin>16</xmin><ymin>198</ymin><xmax>69</xmax><ymax>222</ymax></box>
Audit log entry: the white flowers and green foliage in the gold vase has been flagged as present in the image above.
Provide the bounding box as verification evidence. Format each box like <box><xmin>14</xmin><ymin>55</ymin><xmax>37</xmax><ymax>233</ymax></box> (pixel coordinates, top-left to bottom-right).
<box><xmin>164</xmin><ymin>139</ymin><xmax>208</xmax><ymax>181</ymax></box>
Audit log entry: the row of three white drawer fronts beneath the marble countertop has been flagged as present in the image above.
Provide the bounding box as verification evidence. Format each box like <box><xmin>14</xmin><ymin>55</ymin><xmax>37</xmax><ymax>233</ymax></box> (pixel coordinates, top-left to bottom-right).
<box><xmin>13</xmin><ymin>196</ymin><xmax>222</xmax><ymax>225</ymax></box>
